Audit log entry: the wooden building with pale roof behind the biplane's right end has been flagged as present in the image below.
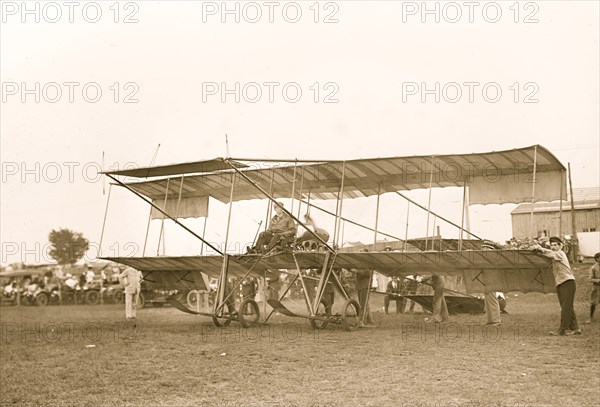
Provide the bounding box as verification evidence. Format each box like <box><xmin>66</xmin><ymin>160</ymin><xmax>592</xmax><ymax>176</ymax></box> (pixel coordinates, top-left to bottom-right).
<box><xmin>510</xmin><ymin>187</ymin><xmax>600</xmax><ymax>239</ymax></box>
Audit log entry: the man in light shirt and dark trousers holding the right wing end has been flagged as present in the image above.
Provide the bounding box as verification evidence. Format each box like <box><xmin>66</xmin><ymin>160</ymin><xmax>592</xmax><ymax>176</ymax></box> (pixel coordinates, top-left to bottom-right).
<box><xmin>533</xmin><ymin>236</ymin><xmax>581</xmax><ymax>335</ymax></box>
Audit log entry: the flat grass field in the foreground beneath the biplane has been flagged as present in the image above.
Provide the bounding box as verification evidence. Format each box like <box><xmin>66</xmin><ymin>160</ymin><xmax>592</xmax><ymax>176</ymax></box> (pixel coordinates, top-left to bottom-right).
<box><xmin>0</xmin><ymin>264</ymin><xmax>600</xmax><ymax>407</ymax></box>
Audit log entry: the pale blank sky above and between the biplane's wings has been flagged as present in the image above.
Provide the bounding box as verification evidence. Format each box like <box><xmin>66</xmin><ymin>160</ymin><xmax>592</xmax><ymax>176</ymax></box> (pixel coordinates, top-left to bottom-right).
<box><xmin>0</xmin><ymin>1</ymin><xmax>600</xmax><ymax>266</ymax></box>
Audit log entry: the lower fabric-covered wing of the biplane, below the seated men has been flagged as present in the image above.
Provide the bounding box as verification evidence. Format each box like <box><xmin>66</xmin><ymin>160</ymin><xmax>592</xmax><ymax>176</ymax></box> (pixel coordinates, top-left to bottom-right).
<box><xmin>103</xmin><ymin>250</ymin><xmax>556</xmax><ymax>293</ymax></box>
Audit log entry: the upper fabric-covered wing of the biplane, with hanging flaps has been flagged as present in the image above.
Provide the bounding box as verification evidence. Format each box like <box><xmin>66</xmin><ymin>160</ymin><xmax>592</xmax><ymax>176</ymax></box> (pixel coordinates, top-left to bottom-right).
<box><xmin>107</xmin><ymin>145</ymin><xmax>566</xmax><ymax>204</ymax></box>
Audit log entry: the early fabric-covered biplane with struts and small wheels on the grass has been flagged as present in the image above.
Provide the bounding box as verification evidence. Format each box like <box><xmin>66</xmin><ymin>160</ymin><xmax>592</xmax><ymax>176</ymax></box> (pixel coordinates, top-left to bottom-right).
<box><xmin>101</xmin><ymin>145</ymin><xmax>566</xmax><ymax>330</ymax></box>
